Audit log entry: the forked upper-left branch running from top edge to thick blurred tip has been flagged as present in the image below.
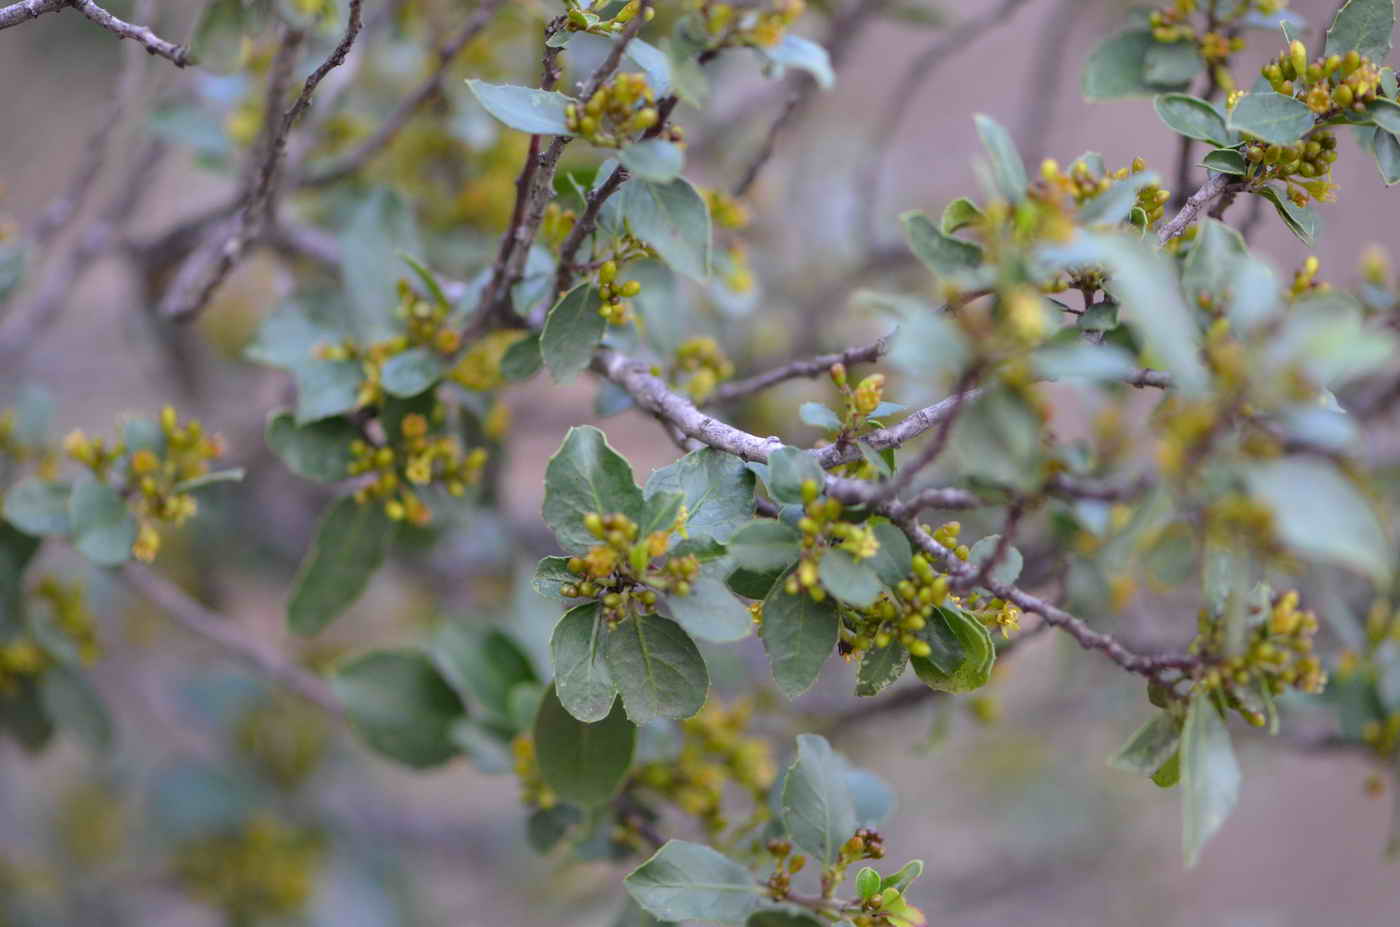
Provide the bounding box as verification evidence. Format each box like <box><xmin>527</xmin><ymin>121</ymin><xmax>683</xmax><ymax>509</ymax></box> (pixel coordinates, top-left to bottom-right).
<box><xmin>160</xmin><ymin>0</ymin><xmax>363</xmax><ymax>321</ymax></box>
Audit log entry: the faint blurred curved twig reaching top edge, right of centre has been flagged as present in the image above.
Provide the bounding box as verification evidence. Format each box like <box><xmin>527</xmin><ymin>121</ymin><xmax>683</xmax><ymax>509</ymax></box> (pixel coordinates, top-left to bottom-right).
<box><xmin>854</xmin><ymin>0</ymin><xmax>1028</xmax><ymax>241</ymax></box>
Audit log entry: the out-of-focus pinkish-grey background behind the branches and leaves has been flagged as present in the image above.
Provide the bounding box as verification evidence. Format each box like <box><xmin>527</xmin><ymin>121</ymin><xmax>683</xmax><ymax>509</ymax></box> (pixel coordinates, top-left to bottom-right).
<box><xmin>0</xmin><ymin>0</ymin><xmax>1400</xmax><ymax>927</ymax></box>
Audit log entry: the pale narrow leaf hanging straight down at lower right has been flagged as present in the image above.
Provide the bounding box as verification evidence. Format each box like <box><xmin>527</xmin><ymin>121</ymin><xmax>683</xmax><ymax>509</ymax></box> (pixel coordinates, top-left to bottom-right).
<box><xmin>1180</xmin><ymin>693</ymin><xmax>1240</xmax><ymax>868</ymax></box>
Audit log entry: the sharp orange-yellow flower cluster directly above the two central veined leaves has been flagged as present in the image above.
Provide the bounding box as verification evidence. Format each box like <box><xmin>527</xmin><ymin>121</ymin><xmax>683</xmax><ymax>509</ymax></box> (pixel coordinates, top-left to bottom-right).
<box><xmin>560</xmin><ymin>506</ymin><xmax>700</xmax><ymax>626</ymax></box>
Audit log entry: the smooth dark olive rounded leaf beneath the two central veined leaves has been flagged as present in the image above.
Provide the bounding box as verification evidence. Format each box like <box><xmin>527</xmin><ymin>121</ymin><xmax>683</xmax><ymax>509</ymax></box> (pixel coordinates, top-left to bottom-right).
<box><xmin>535</xmin><ymin>686</ymin><xmax>637</xmax><ymax>808</ymax></box>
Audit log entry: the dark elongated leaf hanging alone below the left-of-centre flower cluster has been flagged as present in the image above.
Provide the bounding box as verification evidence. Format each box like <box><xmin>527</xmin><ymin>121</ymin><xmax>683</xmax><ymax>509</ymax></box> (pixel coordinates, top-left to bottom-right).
<box><xmin>287</xmin><ymin>496</ymin><xmax>393</xmax><ymax>637</ymax></box>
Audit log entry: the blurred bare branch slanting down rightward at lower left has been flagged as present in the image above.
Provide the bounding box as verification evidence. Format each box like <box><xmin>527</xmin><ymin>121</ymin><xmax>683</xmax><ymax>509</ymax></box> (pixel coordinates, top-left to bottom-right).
<box><xmin>120</xmin><ymin>563</ymin><xmax>344</xmax><ymax>717</ymax></box>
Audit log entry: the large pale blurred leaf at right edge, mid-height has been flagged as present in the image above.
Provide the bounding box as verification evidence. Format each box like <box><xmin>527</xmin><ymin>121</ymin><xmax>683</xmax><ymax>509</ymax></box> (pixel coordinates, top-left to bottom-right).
<box><xmin>1246</xmin><ymin>458</ymin><xmax>1394</xmax><ymax>585</ymax></box>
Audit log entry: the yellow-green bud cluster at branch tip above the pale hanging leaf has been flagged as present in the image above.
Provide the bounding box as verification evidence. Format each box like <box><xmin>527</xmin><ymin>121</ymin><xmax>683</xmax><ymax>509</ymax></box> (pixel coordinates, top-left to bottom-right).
<box><xmin>1190</xmin><ymin>591</ymin><xmax>1327</xmax><ymax>727</ymax></box>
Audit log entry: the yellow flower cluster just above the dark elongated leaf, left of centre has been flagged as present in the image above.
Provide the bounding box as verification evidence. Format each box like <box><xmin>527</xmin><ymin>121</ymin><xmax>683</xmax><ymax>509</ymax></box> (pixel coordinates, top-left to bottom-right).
<box><xmin>349</xmin><ymin>402</ymin><xmax>487</xmax><ymax>525</ymax></box>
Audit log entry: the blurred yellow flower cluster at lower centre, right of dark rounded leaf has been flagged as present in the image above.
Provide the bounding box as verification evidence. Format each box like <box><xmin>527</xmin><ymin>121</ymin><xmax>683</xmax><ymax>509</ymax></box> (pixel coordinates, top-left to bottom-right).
<box><xmin>634</xmin><ymin>700</ymin><xmax>777</xmax><ymax>836</ymax></box>
